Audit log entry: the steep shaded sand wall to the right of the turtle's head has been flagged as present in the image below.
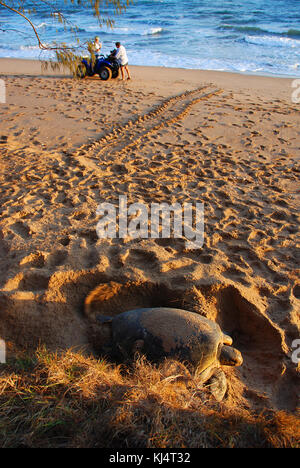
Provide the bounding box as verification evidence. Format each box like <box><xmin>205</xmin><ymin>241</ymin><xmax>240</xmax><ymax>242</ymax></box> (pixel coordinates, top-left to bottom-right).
<box><xmin>215</xmin><ymin>286</ymin><xmax>299</xmax><ymax>411</ymax></box>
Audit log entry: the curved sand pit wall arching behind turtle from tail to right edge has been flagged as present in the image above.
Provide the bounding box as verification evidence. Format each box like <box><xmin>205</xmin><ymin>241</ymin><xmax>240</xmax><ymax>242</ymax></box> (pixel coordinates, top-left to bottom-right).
<box><xmin>85</xmin><ymin>282</ymin><xmax>297</xmax><ymax>409</ymax></box>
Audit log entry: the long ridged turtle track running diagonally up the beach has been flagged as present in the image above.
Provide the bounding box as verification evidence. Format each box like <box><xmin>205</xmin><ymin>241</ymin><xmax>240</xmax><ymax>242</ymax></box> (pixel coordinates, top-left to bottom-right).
<box><xmin>73</xmin><ymin>86</ymin><xmax>223</xmax><ymax>167</ymax></box>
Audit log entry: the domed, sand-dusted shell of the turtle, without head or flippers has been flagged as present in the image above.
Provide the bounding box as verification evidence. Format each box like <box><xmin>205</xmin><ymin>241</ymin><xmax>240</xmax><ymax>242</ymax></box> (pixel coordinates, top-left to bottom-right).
<box><xmin>111</xmin><ymin>307</ymin><xmax>224</xmax><ymax>372</ymax></box>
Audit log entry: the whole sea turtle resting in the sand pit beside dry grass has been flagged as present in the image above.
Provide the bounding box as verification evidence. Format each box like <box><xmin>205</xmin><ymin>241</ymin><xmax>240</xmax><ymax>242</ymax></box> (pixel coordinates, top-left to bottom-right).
<box><xmin>97</xmin><ymin>307</ymin><xmax>243</xmax><ymax>401</ymax></box>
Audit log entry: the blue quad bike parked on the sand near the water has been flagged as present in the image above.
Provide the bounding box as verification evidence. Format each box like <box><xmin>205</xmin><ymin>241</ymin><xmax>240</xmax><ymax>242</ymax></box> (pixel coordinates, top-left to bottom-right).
<box><xmin>76</xmin><ymin>51</ymin><xmax>120</xmax><ymax>81</ymax></box>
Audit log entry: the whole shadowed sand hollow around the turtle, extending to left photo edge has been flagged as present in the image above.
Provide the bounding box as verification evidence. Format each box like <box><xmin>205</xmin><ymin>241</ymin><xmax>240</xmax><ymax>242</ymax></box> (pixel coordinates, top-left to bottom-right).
<box><xmin>0</xmin><ymin>271</ymin><xmax>297</xmax><ymax>408</ymax></box>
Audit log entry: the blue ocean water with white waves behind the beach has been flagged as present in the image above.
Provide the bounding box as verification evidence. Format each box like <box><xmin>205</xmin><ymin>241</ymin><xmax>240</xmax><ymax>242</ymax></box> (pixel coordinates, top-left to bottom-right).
<box><xmin>0</xmin><ymin>0</ymin><xmax>300</xmax><ymax>77</ymax></box>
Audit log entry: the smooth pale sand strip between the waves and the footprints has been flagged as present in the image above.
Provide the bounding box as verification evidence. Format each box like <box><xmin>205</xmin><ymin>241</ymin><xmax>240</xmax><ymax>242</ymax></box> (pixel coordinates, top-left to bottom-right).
<box><xmin>0</xmin><ymin>58</ymin><xmax>294</xmax><ymax>104</ymax></box>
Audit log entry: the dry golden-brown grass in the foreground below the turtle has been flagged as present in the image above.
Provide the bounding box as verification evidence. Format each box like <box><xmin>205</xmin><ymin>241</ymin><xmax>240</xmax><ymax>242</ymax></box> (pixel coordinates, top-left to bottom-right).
<box><xmin>0</xmin><ymin>349</ymin><xmax>300</xmax><ymax>448</ymax></box>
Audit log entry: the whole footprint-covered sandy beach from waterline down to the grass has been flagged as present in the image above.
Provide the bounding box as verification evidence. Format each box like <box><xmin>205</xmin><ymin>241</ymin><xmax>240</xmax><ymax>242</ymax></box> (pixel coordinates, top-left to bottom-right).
<box><xmin>0</xmin><ymin>59</ymin><xmax>300</xmax><ymax>426</ymax></box>
